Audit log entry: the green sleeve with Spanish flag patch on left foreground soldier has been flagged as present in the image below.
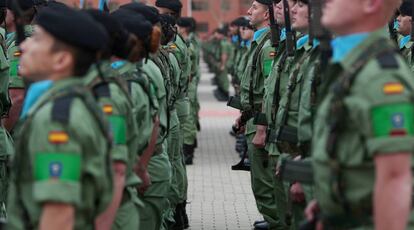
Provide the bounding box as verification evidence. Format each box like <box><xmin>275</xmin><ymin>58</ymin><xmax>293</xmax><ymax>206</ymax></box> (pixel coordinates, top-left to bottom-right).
<box><xmin>30</xmin><ymin>117</ymin><xmax>84</xmax><ymax>205</ymax></box>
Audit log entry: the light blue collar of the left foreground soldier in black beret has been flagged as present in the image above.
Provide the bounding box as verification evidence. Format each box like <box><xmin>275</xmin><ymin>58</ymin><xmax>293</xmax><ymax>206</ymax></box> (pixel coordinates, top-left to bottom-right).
<box><xmin>20</xmin><ymin>80</ymin><xmax>53</xmax><ymax>119</ymax></box>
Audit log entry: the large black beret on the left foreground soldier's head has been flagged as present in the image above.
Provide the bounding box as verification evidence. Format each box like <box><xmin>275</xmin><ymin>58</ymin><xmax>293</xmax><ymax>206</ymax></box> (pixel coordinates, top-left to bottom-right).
<box><xmin>36</xmin><ymin>7</ymin><xmax>108</xmax><ymax>52</ymax></box>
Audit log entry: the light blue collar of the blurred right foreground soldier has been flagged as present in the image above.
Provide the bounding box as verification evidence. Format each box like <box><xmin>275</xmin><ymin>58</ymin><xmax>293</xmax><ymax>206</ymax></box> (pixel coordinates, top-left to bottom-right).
<box><xmin>334</xmin><ymin>28</ymin><xmax>389</xmax><ymax>69</ymax></box>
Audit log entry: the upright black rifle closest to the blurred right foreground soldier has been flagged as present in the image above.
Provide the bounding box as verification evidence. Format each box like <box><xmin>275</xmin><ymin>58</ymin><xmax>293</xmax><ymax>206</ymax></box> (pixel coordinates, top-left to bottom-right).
<box><xmin>309</xmin><ymin>0</ymin><xmax>332</xmax><ymax>72</ymax></box>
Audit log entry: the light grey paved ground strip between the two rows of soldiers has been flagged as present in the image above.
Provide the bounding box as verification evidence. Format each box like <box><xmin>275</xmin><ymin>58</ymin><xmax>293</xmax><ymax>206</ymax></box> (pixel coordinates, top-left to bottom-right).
<box><xmin>187</xmin><ymin>62</ymin><xmax>260</xmax><ymax>230</ymax></box>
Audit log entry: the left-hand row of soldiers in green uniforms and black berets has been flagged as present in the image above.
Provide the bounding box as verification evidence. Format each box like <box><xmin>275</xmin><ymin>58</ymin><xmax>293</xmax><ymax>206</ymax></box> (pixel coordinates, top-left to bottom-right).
<box><xmin>0</xmin><ymin>0</ymin><xmax>200</xmax><ymax>230</ymax></box>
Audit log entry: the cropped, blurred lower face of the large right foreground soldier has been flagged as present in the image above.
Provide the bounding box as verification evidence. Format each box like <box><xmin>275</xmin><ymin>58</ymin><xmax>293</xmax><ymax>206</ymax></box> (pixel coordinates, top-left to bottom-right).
<box><xmin>322</xmin><ymin>0</ymin><xmax>365</xmax><ymax>35</ymax></box>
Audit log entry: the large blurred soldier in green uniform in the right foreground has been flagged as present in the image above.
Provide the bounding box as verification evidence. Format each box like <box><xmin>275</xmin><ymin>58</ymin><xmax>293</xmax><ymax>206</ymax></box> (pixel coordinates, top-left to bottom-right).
<box><xmin>306</xmin><ymin>0</ymin><xmax>414</xmax><ymax>229</ymax></box>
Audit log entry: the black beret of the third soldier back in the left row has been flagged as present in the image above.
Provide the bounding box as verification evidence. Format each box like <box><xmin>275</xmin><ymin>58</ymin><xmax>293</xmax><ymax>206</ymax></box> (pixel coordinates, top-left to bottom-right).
<box><xmin>111</xmin><ymin>9</ymin><xmax>152</xmax><ymax>40</ymax></box>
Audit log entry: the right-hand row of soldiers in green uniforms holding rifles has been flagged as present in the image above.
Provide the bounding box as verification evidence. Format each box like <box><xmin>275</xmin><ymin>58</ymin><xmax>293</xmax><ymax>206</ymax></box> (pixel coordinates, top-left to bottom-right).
<box><xmin>204</xmin><ymin>0</ymin><xmax>414</xmax><ymax>229</ymax></box>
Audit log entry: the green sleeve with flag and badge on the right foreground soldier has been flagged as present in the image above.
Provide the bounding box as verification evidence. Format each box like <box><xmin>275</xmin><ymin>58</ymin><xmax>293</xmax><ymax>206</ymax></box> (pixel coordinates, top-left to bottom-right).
<box><xmin>363</xmin><ymin>71</ymin><xmax>414</xmax><ymax>156</ymax></box>
